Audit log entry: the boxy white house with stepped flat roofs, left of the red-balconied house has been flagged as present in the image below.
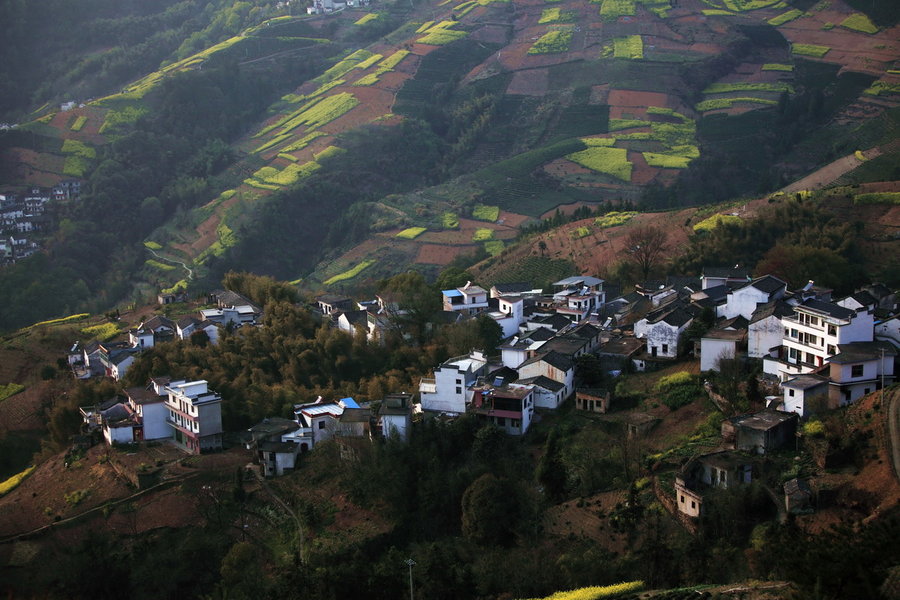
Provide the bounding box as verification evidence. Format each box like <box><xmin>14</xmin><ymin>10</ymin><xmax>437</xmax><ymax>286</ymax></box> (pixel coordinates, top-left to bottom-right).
<box><xmin>419</xmin><ymin>350</ymin><xmax>487</xmax><ymax>414</ymax></box>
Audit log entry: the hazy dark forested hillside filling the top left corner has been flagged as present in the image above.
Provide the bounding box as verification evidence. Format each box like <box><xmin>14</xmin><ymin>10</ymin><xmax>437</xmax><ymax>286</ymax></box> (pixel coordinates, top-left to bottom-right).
<box><xmin>0</xmin><ymin>0</ymin><xmax>290</xmax><ymax>120</ymax></box>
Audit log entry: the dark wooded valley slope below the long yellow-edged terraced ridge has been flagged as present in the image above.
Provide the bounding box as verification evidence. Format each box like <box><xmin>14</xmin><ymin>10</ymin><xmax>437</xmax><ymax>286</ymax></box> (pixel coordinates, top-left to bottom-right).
<box><xmin>0</xmin><ymin>53</ymin><xmax>324</xmax><ymax>331</ymax></box>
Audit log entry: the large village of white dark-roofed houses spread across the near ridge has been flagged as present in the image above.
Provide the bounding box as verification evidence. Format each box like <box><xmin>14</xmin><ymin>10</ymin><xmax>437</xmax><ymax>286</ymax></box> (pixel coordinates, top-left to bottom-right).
<box><xmin>69</xmin><ymin>266</ymin><xmax>900</xmax><ymax>521</ymax></box>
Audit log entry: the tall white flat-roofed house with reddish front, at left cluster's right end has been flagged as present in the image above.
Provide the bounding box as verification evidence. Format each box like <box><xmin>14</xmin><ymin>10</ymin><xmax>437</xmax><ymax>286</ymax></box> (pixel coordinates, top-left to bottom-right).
<box><xmin>165</xmin><ymin>380</ymin><xmax>222</xmax><ymax>454</ymax></box>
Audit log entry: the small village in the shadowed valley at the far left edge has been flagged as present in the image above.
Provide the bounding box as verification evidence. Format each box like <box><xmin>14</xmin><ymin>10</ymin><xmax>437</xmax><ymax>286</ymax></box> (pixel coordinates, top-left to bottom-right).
<box><xmin>0</xmin><ymin>179</ymin><xmax>81</xmax><ymax>265</ymax></box>
